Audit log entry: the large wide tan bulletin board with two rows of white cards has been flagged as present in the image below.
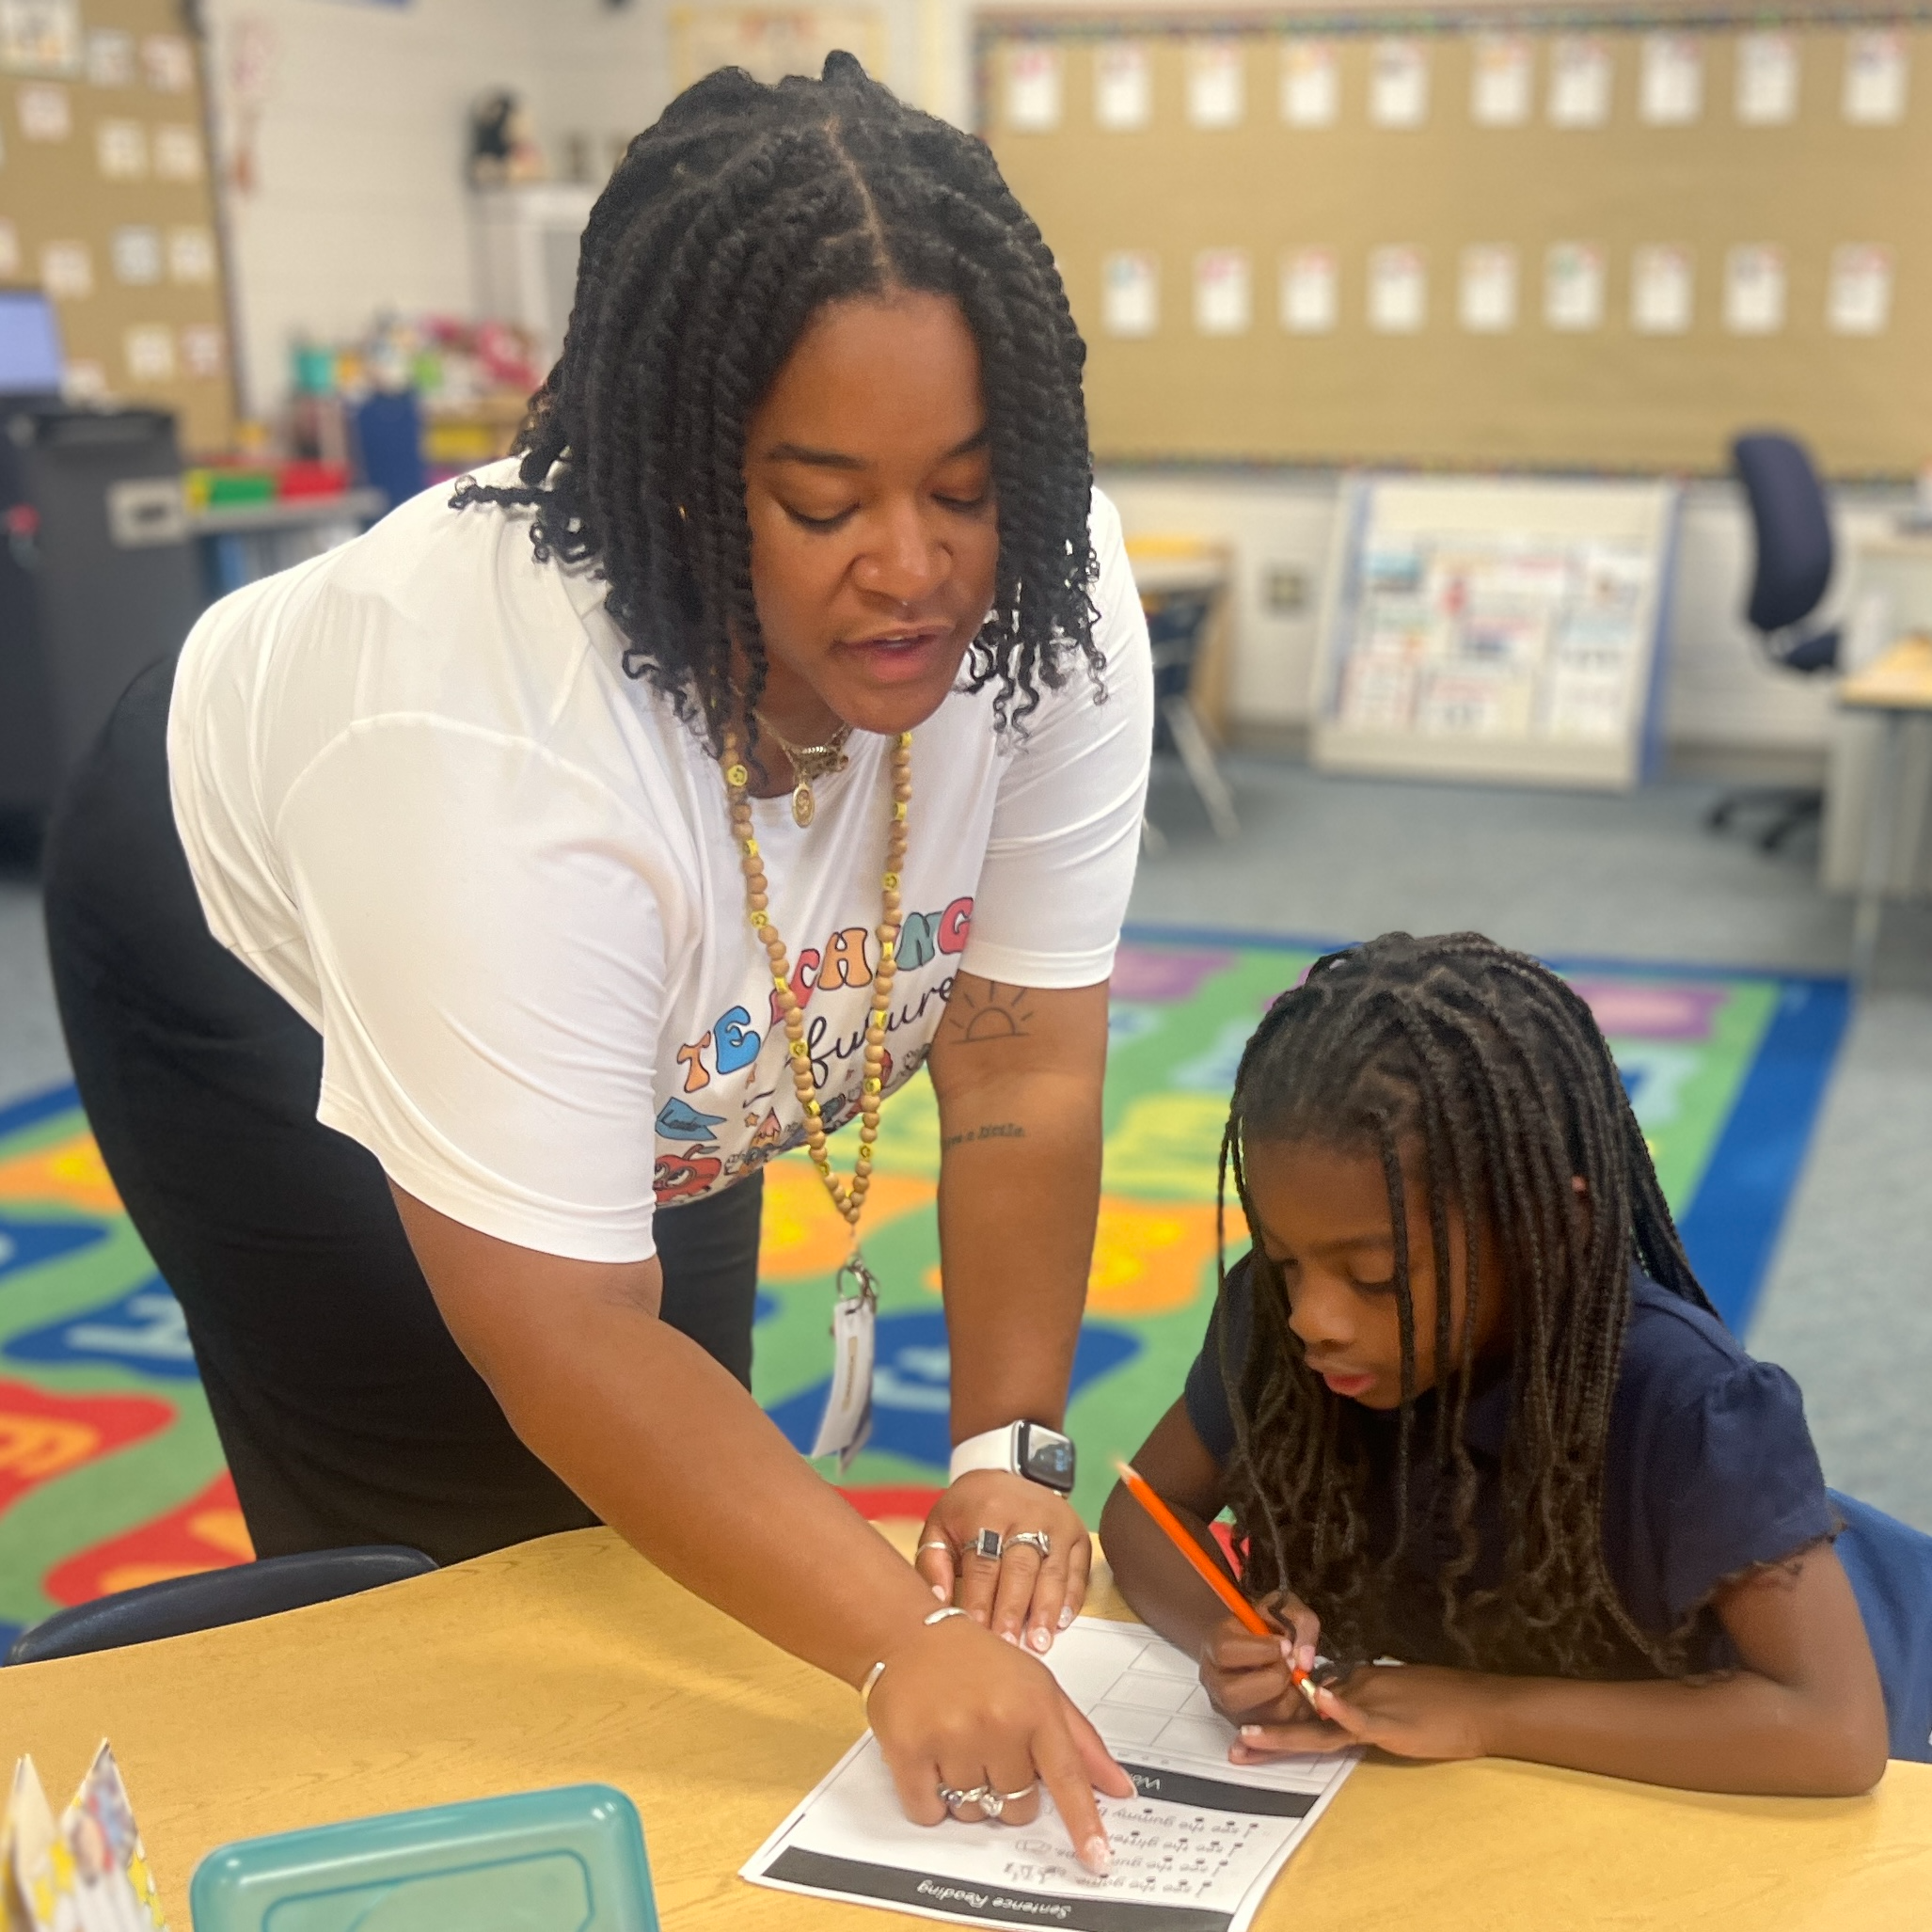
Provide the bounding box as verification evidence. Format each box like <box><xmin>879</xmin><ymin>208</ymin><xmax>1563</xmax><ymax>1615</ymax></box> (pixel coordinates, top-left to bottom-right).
<box><xmin>977</xmin><ymin>9</ymin><xmax>1932</xmax><ymax>477</ymax></box>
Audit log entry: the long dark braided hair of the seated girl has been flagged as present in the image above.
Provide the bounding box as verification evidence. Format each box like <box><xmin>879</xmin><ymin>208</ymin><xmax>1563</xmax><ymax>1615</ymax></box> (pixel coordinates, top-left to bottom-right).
<box><xmin>1217</xmin><ymin>933</ymin><xmax>1710</xmax><ymax>1677</ymax></box>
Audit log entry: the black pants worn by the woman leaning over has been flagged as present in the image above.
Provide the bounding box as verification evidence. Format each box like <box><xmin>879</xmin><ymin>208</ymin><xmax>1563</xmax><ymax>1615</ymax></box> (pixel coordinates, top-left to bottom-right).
<box><xmin>46</xmin><ymin>660</ymin><xmax>763</xmax><ymax>1563</ymax></box>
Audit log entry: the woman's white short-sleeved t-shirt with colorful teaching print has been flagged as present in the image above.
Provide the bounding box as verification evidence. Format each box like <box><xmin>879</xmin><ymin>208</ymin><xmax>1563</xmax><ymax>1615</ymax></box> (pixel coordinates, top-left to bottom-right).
<box><xmin>168</xmin><ymin>466</ymin><xmax>1153</xmax><ymax>1261</ymax></box>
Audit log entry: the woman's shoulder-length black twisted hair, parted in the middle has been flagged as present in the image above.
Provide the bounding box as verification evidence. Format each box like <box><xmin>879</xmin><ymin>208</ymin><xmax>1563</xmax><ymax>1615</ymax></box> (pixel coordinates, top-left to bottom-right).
<box><xmin>454</xmin><ymin>55</ymin><xmax>1101</xmax><ymax>750</ymax></box>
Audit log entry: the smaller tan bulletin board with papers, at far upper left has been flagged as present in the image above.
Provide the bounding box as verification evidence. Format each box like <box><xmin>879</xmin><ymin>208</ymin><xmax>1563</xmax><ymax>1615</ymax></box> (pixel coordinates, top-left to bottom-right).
<box><xmin>0</xmin><ymin>0</ymin><xmax>234</xmax><ymax>452</ymax></box>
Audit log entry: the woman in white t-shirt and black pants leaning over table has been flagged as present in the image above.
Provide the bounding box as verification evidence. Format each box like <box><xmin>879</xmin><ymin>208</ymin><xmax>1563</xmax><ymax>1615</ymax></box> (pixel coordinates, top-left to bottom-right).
<box><xmin>46</xmin><ymin>55</ymin><xmax>1151</xmax><ymax>1862</ymax></box>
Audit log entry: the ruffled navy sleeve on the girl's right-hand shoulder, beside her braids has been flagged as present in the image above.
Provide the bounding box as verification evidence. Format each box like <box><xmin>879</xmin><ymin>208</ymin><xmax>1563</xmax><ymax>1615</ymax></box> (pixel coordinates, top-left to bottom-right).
<box><xmin>1644</xmin><ymin>1358</ymin><xmax>1837</xmax><ymax>1626</ymax></box>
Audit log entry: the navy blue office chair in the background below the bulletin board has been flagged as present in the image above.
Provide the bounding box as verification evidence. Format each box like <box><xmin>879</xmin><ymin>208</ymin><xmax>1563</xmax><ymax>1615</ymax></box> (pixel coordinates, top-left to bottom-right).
<box><xmin>1710</xmin><ymin>431</ymin><xmax>1839</xmax><ymax>852</ymax></box>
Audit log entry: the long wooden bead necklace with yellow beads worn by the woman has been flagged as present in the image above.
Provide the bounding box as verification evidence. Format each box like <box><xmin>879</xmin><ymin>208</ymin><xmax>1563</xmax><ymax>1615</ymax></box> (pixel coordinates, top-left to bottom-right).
<box><xmin>724</xmin><ymin>728</ymin><xmax>911</xmax><ymax>1265</ymax></box>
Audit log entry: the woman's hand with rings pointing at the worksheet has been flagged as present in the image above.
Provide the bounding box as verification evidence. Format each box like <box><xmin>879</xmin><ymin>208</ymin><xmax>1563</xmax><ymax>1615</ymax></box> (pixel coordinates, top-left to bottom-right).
<box><xmin>867</xmin><ymin>1592</ymin><xmax>1134</xmax><ymax>1872</ymax></box>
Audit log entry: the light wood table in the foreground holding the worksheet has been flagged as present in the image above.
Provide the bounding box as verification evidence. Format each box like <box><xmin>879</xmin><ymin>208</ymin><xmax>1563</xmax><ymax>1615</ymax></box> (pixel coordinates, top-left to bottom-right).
<box><xmin>0</xmin><ymin>1530</ymin><xmax>1932</xmax><ymax>1932</ymax></box>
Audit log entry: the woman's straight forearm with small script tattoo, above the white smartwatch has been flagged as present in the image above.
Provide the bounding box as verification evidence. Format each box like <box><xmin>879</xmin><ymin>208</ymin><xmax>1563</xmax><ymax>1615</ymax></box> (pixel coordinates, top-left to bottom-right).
<box><xmin>939</xmin><ymin>1076</ymin><xmax>1101</xmax><ymax>1441</ymax></box>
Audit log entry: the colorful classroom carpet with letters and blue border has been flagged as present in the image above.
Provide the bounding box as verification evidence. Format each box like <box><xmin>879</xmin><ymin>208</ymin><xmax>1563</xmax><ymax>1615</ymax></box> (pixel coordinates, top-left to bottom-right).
<box><xmin>0</xmin><ymin>931</ymin><xmax>1847</xmax><ymax>1648</ymax></box>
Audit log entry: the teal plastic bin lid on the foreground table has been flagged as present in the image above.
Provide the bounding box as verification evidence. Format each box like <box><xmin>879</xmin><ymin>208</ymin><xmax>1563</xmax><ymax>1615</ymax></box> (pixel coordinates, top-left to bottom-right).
<box><xmin>187</xmin><ymin>1785</ymin><xmax>658</xmax><ymax>1932</ymax></box>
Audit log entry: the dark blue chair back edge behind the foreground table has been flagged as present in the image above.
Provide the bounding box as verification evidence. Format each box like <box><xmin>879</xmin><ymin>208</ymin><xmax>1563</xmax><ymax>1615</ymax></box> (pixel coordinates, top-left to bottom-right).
<box><xmin>6</xmin><ymin>1544</ymin><xmax>436</xmax><ymax>1663</ymax></box>
